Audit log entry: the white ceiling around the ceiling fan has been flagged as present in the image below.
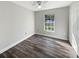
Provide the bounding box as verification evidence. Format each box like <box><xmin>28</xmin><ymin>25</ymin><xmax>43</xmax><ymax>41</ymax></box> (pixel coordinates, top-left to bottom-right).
<box><xmin>12</xmin><ymin>1</ymin><xmax>73</xmax><ymax>11</ymax></box>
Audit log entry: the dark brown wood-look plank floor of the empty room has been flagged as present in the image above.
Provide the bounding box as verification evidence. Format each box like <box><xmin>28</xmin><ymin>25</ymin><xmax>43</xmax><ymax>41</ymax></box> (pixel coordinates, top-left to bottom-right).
<box><xmin>0</xmin><ymin>35</ymin><xmax>77</xmax><ymax>58</ymax></box>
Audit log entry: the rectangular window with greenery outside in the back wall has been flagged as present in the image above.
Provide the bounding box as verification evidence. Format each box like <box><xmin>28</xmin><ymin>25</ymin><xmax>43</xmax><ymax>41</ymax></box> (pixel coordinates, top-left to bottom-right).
<box><xmin>44</xmin><ymin>15</ymin><xmax>55</xmax><ymax>32</ymax></box>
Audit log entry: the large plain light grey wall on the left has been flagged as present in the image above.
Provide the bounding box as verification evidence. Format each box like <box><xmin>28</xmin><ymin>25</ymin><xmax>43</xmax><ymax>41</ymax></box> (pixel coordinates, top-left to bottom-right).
<box><xmin>0</xmin><ymin>2</ymin><xmax>34</xmax><ymax>53</ymax></box>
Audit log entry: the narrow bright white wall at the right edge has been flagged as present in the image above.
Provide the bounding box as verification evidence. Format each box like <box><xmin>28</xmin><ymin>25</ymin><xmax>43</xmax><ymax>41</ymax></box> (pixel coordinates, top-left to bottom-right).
<box><xmin>69</xmin><ymin>2</ymin><xmax>79</xmax><ymax>55</ymax></box>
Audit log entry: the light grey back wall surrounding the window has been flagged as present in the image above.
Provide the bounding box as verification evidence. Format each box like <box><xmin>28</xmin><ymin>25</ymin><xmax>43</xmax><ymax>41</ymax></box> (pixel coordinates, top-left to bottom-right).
<box><xmin>35</xmin><ymin>7</ymin><xmax>69</xmax><ymax>40</ymax></box>
